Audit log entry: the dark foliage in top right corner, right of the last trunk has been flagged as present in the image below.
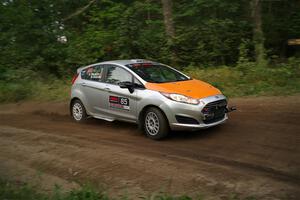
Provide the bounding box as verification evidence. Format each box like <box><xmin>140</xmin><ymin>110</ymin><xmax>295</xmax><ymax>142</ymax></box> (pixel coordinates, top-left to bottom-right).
<box><xmin>262</xmin><ymin>0</ymin><xmax>300</xmax><ymax>57</ymax></box>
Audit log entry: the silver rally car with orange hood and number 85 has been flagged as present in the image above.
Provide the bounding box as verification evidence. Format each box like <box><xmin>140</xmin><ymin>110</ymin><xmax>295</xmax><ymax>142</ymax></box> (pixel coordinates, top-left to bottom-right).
<box><xmin>70</xmin><ymin>59</ymin><xmax>234</xmax><ymax>139</ymax></box>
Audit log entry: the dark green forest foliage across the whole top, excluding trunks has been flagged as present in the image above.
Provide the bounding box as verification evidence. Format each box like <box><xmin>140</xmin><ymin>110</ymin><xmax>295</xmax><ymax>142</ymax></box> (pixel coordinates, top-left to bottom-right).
<box><xmin>0</xmin><ymin>0</ymin><xmax>300</xmax><ymax>73</ymax></box>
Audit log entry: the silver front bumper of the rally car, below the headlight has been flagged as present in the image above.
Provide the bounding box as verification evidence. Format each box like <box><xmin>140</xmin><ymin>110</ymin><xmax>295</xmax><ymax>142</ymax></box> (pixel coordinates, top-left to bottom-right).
<box><xmin>161</xmin><ymin>94</ymin><xmax>228</xmax><ymax>130</ymax></box>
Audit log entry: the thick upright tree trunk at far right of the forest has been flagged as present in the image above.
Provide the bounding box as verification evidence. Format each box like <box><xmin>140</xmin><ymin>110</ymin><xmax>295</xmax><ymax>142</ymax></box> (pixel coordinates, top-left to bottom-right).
<box><xmin>251</xmin><ymin>0</ymin><xmax>267</xmax><ymax>66</ymax></box>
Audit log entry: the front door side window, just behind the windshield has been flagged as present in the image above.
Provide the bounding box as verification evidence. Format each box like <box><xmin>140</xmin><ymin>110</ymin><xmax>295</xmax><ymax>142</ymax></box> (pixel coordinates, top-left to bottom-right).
<box><xmin>106</xmin><ymin>65</ymin><xmax>132</xmax><ymax>84</ymax></box>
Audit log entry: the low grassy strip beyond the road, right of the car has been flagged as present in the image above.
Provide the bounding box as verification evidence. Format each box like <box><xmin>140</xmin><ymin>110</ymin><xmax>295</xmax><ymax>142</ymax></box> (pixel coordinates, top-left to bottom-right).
<box><xmin>185</xmin><ymin>58</ymin><xmax>300</xmax><ymax>97</ymax></box>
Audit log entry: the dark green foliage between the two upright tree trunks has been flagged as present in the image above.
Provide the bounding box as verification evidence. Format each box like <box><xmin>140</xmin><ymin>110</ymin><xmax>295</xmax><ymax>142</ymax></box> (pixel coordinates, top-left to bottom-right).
<box><xmin>175</xmin><ymin>0</ymin><xmax>251</xmax><ymax>65</ymax></box>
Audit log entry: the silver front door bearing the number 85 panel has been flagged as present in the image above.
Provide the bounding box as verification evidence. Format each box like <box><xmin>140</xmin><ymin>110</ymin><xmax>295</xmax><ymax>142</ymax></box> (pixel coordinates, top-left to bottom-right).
<box><xmin>105</xmin><ymin>65</ymin><xmax>137</xmax><ymax>121</ymax></box>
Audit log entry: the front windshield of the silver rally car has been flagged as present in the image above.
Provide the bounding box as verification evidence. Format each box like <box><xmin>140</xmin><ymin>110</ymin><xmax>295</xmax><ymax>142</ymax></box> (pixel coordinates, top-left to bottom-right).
<box><xmin>127</xmin><ymin>63</ymin><xmax>189</xmax><ymax>83</ymax></box>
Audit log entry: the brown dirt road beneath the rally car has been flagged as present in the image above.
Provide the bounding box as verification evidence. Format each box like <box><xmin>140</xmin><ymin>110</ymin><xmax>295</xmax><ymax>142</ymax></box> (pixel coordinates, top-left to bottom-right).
<box><xmin>0</xmin><ymin>96</ymin><xmax>300</xmax><ymax>199</ymax></box>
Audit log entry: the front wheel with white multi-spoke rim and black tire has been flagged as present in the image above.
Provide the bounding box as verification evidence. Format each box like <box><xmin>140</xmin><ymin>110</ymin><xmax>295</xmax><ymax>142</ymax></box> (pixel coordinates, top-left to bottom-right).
<box><xmin>143</xmin><ymin>107</ymin><xmax>170</xmax><ymax>140</ymax></box>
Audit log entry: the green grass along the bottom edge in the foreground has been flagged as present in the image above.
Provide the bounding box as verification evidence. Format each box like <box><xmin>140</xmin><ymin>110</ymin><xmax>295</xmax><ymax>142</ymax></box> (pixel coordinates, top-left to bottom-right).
<box><xmin>0</xmin><ymin>179</ymin><xmax>257</xmax><ymax>200</ymax></box>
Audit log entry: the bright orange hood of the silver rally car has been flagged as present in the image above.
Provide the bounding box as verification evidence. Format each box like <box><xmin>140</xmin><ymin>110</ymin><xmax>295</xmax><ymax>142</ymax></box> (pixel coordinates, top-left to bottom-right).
<box><xmin>145</xmin><ymin>80</ymin><xmax>221</xmax><ymax>99</ymax></box>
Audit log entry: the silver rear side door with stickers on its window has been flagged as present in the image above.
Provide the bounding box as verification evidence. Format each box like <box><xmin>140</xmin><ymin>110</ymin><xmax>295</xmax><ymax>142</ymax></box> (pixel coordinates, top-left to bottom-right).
<box><xmin>81</xmin><ymin>65</ymin><xmax>106</xmax><ymax>116</ymax></box>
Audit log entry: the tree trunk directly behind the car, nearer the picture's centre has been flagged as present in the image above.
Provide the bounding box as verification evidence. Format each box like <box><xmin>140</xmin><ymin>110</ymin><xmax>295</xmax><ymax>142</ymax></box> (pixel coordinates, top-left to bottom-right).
<box><xmin>161</xmin><ymin>0</ymin><xmax>175</xmax><ymax>39</ymax></box>
